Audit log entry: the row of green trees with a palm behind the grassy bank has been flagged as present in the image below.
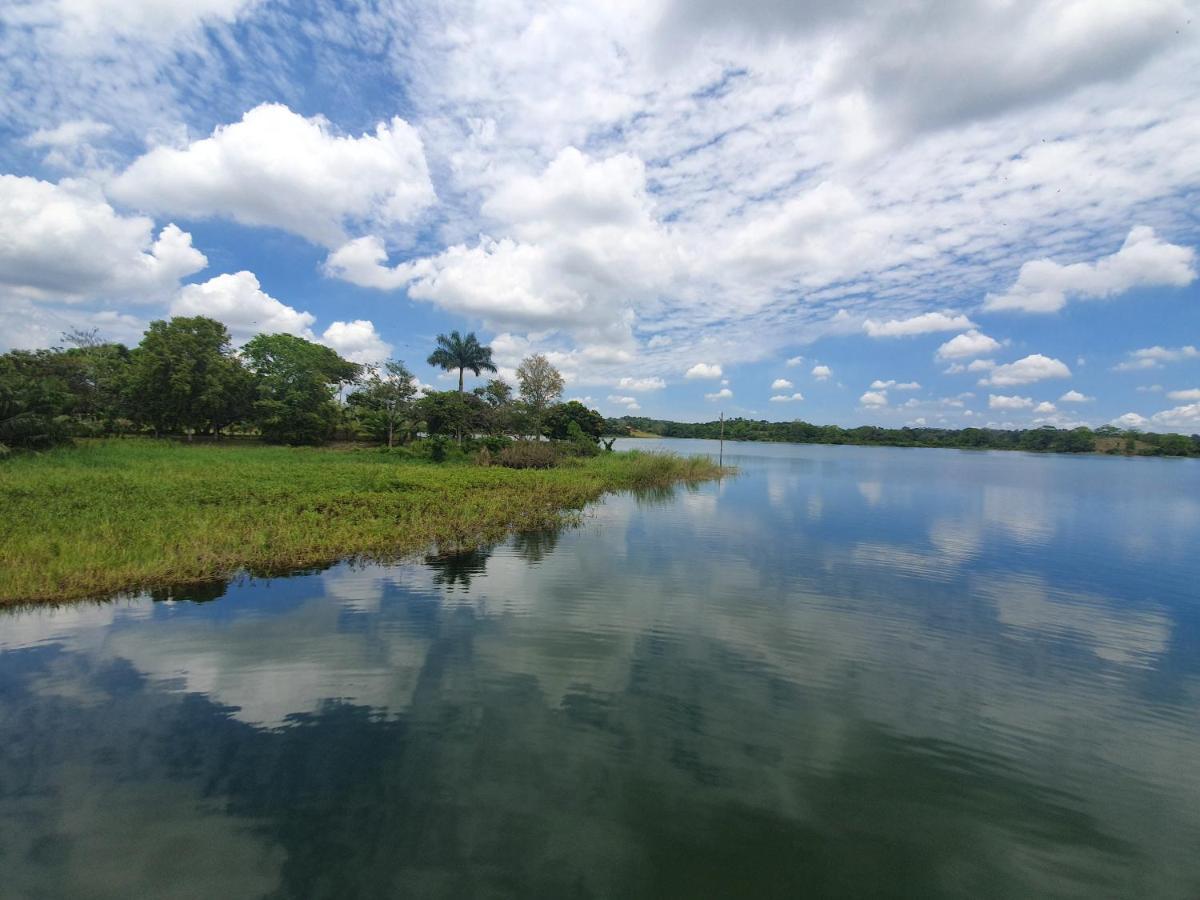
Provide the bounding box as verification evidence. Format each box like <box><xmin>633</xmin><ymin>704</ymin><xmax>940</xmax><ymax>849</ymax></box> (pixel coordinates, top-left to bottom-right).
<box><xmin>0</xmin><ymin>316</ymin><xmax>604</xmax><ymax>455</ymax></box>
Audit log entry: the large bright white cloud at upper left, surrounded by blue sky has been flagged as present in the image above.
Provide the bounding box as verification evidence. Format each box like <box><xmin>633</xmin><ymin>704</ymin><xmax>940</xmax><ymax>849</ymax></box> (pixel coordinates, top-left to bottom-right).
<box><xmin>109</xmin><ymin>103</ymin><xmax>436</xmax><ymax>246</ymax></box>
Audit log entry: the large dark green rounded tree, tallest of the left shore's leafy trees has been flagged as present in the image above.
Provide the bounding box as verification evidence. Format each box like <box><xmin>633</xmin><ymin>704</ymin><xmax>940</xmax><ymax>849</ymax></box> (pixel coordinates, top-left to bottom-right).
<box><xmin>125</xmin><ymin>316</ymin><xmax>252</xmax><ymax>433</ymax></box>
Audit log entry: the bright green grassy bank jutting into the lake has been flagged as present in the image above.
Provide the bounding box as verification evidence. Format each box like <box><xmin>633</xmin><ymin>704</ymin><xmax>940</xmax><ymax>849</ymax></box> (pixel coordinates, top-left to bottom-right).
<box><xmin>0</xmin><ymin>439</ymin><xmax>719</xmax><ymax>604</ymax></box>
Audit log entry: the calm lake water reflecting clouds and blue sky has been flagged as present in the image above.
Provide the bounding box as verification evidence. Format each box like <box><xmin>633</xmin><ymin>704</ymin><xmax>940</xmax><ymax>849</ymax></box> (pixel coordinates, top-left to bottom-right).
<box><xmin>0</xmin><ymin>442</ymin><xmax>1200</xmax><ymax>899</ymax></box>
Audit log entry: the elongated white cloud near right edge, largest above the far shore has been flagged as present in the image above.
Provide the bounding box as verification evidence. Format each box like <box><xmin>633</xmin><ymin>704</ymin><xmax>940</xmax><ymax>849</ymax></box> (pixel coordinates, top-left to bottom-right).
<box><xmin>984</xmin><ymin>226</ymin><xmax>1196</xmax><ymax>312</ymax></box>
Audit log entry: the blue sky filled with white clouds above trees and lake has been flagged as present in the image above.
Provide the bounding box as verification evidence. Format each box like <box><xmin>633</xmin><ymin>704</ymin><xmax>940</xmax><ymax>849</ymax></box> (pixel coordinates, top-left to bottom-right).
<box><xmin>0</xmin><ymin>0</ymin><xmax>1200</xmax><ymax>433</ymax></box>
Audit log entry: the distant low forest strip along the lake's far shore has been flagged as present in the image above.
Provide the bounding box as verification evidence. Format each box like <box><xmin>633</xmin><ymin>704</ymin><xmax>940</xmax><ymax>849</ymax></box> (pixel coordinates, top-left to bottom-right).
<box><xmin>606</xmin><ymin>415</ymin><xmax>1200</xmax><ymax>456</ymax></box>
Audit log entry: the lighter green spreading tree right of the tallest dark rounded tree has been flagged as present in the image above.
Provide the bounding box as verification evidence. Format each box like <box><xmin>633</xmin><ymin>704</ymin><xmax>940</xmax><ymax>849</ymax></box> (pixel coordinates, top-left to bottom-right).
<box><xmin>241</xmin><ymin>334</ymin><xmax>360</xmax><ymax>444</ymax></box>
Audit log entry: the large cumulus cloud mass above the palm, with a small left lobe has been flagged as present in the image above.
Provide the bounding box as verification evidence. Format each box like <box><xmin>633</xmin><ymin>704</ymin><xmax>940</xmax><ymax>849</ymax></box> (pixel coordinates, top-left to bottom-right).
<box><xmin>325</xmin><ymin>148</ymin><xmax>682</xmax><ymax>343</ymax></box>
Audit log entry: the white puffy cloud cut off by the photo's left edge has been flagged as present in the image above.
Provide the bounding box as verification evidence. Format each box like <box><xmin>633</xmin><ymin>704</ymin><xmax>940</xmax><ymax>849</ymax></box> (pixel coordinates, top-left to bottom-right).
<box><xmin>0</xmin><ymin>175</ymin><xmax>208</xmax><ymax>301</ymax></box>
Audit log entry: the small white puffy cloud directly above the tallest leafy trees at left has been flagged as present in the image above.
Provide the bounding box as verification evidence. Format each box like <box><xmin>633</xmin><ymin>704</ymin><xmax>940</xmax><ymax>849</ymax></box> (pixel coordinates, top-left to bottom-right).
<box><xmin>170</xmin><ymin>271</ymin><xmax>317</xmax><ymax>343</ymax></box>
